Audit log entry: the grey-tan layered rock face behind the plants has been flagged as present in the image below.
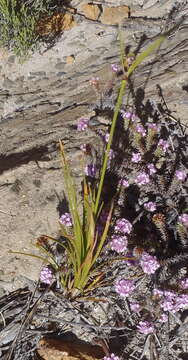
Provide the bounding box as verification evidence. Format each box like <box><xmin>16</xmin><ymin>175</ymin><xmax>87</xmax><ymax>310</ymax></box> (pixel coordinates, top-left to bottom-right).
<box><xmin>0</xmin><ymin>0</ymin><xmax>188</xmax><ymax>290</ymax></box>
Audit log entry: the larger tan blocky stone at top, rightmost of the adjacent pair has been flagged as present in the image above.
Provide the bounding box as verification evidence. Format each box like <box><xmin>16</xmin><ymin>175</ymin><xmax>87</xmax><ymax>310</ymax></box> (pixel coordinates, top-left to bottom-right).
<box><xmin>99</xmin><ymin>5</ymin><xmax>130</xmax><ymax>25</ymax></box>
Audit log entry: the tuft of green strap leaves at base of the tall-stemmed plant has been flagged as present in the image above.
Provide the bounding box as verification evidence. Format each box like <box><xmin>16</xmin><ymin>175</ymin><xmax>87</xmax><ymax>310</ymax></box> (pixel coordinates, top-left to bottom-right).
<box><xmin>56</xmin><ymin>143</ymin><xmax>113</xmax><ymax>293</ymax></box>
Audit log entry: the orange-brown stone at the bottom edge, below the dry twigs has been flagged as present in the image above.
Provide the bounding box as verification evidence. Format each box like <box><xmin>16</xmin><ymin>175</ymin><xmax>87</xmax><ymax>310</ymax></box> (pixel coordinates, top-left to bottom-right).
<box><xmin>37</xmin><ymin>338</ymin><xmax>104</xmax><ymax>360</ymax></box>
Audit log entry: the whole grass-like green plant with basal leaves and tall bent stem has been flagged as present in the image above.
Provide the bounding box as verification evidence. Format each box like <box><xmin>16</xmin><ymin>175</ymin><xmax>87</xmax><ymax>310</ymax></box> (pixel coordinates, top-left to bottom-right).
<box><xmin>10</xmin><ymin>26</ymin><xmax>176</xmax><ymax>298</ymax></box>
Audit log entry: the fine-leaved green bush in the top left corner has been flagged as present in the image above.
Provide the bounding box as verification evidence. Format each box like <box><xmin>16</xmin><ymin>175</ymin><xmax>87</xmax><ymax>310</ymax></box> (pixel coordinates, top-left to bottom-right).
<box><xmin>0</xmin><ymin>0</ymin><xmax>54</xmax><ymax>59</ymax></box>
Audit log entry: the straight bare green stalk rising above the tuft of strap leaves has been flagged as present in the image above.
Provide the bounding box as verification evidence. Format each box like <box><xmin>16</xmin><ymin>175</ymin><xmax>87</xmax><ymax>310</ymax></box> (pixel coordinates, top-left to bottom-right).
<box><xmin>94</xmin><ymin>80</ymin><xmax>127</xmax><ymax>215</ymax></box>
